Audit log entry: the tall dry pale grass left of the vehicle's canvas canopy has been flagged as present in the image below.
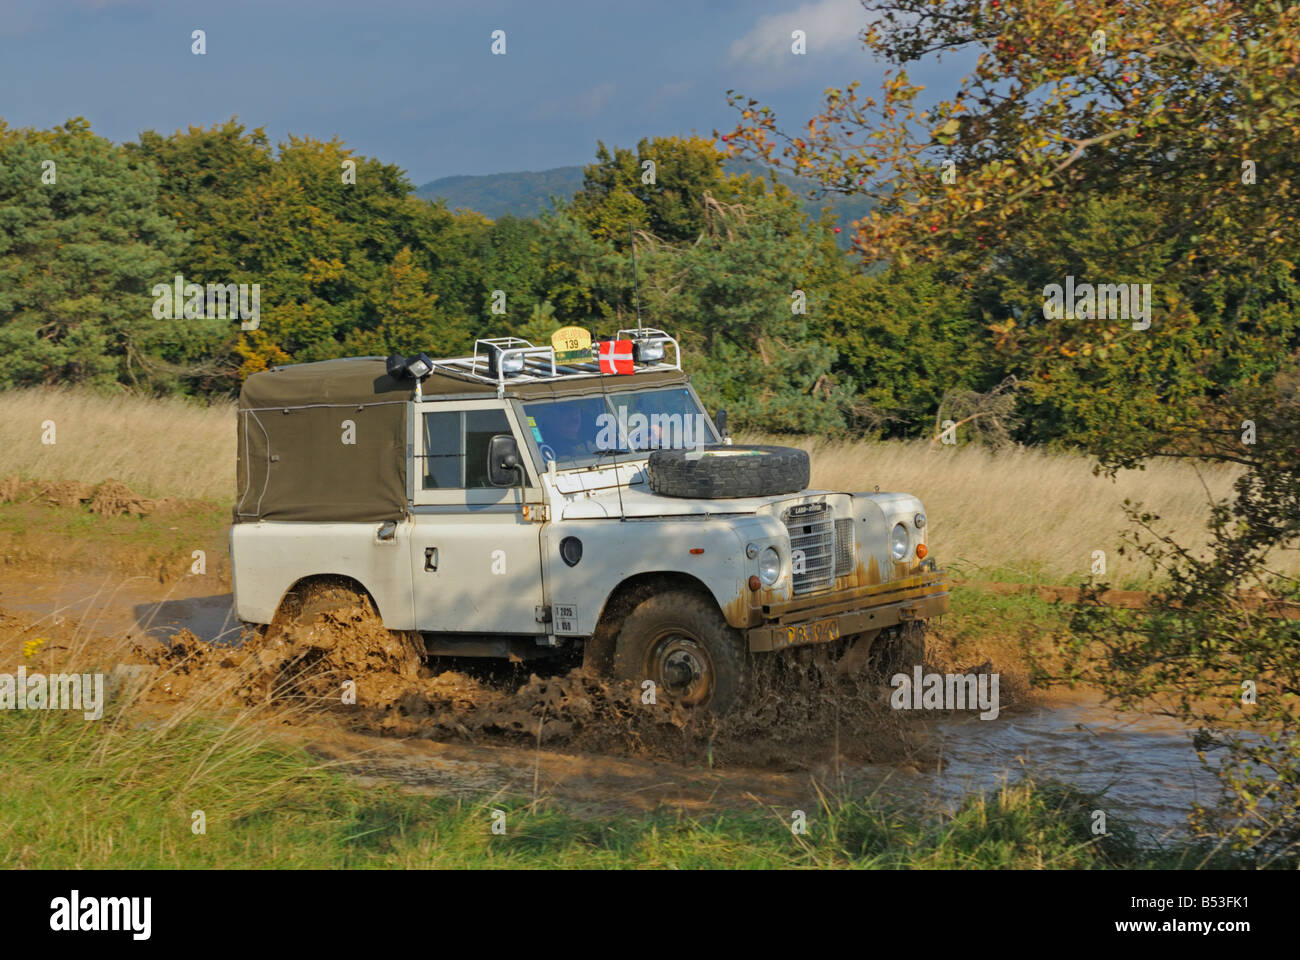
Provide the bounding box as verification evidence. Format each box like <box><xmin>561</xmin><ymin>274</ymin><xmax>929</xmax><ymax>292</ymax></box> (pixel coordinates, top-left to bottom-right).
<box><xmin>0</xmin><ymin>388</ymin><xmax>235</xmax><ymax>503</ymax></box>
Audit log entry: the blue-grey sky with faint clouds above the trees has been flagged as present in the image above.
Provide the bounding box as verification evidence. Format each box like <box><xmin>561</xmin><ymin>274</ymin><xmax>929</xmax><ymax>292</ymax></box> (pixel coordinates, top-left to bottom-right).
<box><xmin>0</xmin><ymin>0</ymin><xmax>958</xmax><ymax>185</ymax></box>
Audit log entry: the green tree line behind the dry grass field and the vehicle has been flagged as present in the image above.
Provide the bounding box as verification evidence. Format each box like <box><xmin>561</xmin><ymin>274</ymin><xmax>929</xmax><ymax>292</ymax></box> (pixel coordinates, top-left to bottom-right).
<box><xmin>0</xmin><ymin>118</ymin><xmax>1086</xmax><ymax>440</ymax></box>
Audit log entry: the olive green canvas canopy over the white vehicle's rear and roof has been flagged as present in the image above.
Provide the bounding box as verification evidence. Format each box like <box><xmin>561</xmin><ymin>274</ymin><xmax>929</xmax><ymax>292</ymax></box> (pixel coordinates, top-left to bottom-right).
<box><xmin>234</xmin><ymin>356</ymin><xmax>688</xmax><ymax>523</ymax></box>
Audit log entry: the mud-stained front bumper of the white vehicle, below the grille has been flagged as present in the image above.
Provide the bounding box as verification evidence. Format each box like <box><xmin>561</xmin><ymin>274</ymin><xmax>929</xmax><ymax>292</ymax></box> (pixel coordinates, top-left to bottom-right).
<box><xmin>745</xmin><ymin>571</ymin><xmax>949</xmax><ymax>653</ymax></box>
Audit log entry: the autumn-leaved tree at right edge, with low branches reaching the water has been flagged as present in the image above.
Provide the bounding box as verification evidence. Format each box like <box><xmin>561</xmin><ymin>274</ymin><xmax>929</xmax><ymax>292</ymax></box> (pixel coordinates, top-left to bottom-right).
<box><xmin>724</xmin><ymin>0</ymin><xmax>1300</xmax><ymax>860</ymax></box>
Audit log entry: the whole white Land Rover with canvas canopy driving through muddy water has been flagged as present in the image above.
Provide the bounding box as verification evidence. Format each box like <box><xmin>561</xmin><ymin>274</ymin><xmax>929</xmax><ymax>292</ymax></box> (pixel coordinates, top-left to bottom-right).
<box><xmin>230</xmin><ymin>329</ymin><xmax>948</xmax><ymax>710</ymax></box>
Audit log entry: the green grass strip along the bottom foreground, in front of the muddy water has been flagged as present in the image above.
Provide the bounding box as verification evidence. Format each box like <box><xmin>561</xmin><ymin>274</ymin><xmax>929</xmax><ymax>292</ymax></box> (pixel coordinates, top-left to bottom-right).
<box><xmin>0</xmin><ymin>712</ymin><xmax>1232</xmax><ymax>869</ymax></box>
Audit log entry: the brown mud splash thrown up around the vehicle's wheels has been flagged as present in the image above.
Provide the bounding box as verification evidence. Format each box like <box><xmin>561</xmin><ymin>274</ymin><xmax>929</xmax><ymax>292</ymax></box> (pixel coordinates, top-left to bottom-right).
<box><xmin>137</xmin><ymin>597</ymin><xmax>924</xmax><ymax>771</ymax></box>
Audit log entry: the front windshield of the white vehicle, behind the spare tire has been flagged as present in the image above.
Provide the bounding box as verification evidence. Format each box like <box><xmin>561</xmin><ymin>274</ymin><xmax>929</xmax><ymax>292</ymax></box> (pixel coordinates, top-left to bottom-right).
<box><xmin>524</xmin><ymin>386</ymin><xmax>718</xmax><ymax>470</ymax></box>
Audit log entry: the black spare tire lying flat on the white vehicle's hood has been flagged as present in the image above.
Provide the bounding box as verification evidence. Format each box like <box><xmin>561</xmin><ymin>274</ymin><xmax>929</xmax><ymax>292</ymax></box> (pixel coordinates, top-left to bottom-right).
<box><xmin>646</xmin><ymin>444</ymin><xmax>810</xmax><ymax>500</ymax></box>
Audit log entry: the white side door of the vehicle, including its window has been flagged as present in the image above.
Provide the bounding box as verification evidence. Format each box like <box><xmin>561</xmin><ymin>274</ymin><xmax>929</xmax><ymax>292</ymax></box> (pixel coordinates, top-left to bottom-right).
<box><xmin>411</xmin><ymin>399</ymin><xmax>546</xmax><ymax>635</ymax></box>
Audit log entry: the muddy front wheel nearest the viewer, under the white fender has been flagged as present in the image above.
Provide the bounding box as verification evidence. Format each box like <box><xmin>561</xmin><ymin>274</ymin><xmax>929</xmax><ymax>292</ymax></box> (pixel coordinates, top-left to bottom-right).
<box><xmin>614</xmin><ymin>591</ymin><xmax>749</xmax><ymax>714</ymax></box>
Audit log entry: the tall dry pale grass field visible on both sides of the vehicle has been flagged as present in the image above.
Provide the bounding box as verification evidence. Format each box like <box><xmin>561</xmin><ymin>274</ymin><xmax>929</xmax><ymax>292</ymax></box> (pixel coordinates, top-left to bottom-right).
<box><xmin>0</xmin><ymin>389</ymin><xmax>1268</xmax><ymax>587</ymax></box>
